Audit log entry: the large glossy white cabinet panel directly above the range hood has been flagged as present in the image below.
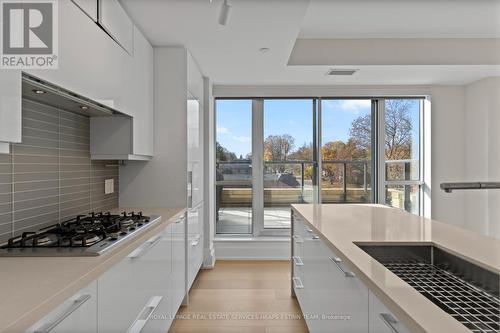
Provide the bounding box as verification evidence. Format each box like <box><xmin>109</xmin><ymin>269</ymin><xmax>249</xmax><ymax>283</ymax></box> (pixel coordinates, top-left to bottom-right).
<box><xmin>26</xmin><ymin>1</ymin><xmax>133</xmax><ymax>115</ymax></box>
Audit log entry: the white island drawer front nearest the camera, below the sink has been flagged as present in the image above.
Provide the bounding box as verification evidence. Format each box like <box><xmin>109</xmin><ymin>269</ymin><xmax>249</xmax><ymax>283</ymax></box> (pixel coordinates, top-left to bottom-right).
<box><xmin>368</xmin><ymin>291</ymin><xmax>410</xmax><ymax>333</ymax></box>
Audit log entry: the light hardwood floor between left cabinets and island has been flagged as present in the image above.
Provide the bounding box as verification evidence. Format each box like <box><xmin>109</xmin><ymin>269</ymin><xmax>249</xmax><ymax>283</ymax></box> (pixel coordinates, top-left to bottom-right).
<box><xmin>169</xmin><ymin>260</ymin><xmax>308</xmax><ymax>333</ymax></box>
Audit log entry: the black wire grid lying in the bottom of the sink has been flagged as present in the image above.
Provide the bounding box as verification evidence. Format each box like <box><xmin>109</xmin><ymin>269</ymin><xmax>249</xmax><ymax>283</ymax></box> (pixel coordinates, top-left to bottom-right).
<box><xmin>383</xmin><ymin>261</ymin><xmax>500</xmax><ymax>333</ymax></box>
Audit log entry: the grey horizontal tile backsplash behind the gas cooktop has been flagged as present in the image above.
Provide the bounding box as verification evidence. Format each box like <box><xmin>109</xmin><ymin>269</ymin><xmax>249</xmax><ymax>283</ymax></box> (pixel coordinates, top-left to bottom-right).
<box><xmin>0</xmin><ymin>100</ymin><xmax>119</xmax><ymax>244</ymax></box>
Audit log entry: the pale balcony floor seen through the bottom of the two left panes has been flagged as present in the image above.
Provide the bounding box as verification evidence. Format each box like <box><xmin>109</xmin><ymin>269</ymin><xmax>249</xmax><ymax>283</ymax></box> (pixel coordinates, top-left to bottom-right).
<box><xmin>217</xmin><ymin>207</ymin><xmax>290</xmax><ymax>234</ymax></box>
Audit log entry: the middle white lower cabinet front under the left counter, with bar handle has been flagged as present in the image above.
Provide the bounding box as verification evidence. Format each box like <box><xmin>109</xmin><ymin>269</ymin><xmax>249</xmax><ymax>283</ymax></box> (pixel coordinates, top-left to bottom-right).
<box><xmin>98</xmin><ymin>226</ymin><xmax>172</xmax><ymax>332</ymax></box>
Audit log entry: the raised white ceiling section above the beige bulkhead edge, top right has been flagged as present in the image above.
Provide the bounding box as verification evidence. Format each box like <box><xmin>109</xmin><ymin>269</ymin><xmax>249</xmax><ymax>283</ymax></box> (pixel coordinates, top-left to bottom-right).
<box><xmin>299</xmin><ymin>0</ymin><xmax>500</xmax><ymax>38</ymax></box>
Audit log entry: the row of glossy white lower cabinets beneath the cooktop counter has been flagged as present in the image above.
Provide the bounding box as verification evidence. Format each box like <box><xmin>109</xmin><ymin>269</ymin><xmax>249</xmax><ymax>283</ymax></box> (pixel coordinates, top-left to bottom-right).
<box><xmin>26</xmin><ymin>211</ymin><xmax>186</xmax><ymax>333</ymax></box>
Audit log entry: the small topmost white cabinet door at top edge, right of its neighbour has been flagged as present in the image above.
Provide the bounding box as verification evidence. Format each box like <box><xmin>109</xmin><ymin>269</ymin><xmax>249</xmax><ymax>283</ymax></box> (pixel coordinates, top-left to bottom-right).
<box><xmin>99</xmin><ymin>0</ymin><xmax>134</xmax><ymax>54</ymax></box>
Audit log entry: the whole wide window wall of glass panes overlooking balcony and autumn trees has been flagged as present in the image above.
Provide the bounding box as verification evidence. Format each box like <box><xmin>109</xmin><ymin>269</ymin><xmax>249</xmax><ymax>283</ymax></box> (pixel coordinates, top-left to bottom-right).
<box><xmin>215</xmin><ymin>98</ymin><xmax>424</xmax><ymax>236</ymax></box>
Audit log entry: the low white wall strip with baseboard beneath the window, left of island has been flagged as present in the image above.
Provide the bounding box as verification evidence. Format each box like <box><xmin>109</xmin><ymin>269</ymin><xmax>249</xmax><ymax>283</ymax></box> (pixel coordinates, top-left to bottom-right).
<box><xmin>214</xmin><ymin>238</ymin><xmax>290</xmax><ymax>260</ymax></box>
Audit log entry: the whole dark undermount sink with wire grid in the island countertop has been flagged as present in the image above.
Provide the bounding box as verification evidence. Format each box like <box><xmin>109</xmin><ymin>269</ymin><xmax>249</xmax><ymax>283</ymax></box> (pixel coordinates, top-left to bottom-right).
<box><xmin>357</xmin><ymin>243</ymin><xmax>500</xmax><ymax>333</ymax></box>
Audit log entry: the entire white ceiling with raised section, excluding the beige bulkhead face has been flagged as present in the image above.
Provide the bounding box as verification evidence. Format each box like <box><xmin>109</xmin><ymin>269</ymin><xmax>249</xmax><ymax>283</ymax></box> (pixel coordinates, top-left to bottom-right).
<box><xmin>121</xmin><ymin>0</ymin><xmax>500</xmax><ymax>85</ymax></box>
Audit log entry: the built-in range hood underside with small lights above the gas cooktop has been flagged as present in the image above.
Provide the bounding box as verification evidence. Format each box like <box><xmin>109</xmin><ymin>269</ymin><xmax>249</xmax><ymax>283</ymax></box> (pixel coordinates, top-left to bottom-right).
<box><xmin>22</xmin><ymin>73</ymin><xmax>123</xmax><ymax>117</ymax></box>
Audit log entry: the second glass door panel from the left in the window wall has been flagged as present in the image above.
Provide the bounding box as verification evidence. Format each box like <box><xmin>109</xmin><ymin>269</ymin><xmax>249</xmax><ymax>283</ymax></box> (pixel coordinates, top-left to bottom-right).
<box><xmin>263</xmin><ymin>99</ymin><xmax>316</xmax><ymax>229</ymax></box>
